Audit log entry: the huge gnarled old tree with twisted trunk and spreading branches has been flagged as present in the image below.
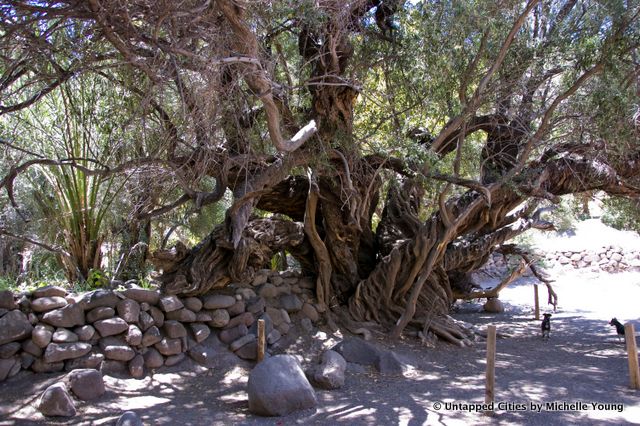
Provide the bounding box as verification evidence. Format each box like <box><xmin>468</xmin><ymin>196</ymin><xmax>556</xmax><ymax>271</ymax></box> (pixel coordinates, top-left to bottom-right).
<box><xmin>0</xmin><ymin>0</ymin><xmax>640</xmax><ymax>341</ymax></box>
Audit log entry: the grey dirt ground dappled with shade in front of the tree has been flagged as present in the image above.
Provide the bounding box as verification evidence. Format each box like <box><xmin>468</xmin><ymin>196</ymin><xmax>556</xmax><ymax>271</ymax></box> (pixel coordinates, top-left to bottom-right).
<box><xmin>0</xmin><ymin>272</ymin><xmax>640</xmax><ymax>426</ymax></box>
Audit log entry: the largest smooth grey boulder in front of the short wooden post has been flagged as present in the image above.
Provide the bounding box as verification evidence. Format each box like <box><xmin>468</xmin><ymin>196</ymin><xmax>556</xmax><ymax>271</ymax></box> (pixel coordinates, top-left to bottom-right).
<box><xmin>247</xmin><ymin>355</ymin><xmax>317</xmax><ymax>416</ymax></box>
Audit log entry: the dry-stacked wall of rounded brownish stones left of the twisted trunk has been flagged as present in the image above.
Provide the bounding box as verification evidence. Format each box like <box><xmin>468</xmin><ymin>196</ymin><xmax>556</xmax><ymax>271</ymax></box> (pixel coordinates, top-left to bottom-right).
<box><xmin>0</xmin><ymin>270</ymin><xmax>320</xmax><ymax>381</ymax></box>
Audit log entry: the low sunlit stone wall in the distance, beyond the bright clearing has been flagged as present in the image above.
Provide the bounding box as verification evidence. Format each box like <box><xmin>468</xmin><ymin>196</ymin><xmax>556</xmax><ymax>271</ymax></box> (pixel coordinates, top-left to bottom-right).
<box><xmin>486</xmin><ymin>245</ymin><xmax>640</xmax><ymax>272</ymax></box>
